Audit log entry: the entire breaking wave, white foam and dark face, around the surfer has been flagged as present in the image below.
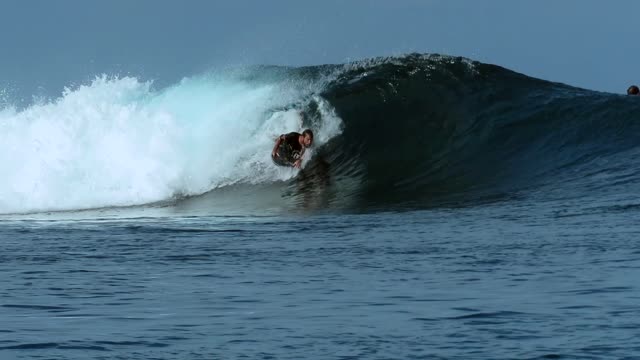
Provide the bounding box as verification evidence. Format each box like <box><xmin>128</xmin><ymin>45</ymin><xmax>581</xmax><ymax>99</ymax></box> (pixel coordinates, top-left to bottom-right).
<box><xmin>0</xmin><ymin>54</ymin><xmax>640</xmax><ymax>213</ymax></box>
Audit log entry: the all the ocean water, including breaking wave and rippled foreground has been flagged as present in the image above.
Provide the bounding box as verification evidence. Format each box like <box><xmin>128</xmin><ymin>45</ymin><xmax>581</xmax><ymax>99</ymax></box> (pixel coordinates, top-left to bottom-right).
<box><xmin>0</xmin><ymin>54</ymin><xmax>640</xmax><ymax>359</ymax></box>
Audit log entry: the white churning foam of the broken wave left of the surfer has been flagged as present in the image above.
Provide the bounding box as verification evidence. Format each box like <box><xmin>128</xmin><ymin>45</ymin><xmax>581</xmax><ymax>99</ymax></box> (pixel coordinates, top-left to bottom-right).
<box><xmin>0</xmin><ymin>76</ymin><xmax>340</xmax><ymax>213</ymax></box>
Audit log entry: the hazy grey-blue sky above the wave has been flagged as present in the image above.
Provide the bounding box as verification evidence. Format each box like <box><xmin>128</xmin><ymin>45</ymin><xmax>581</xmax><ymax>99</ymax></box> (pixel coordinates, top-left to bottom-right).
<box><xmin>0</xmin><ymin>0</ymin><xmax>640</xmax><ymax>97</ymax></box>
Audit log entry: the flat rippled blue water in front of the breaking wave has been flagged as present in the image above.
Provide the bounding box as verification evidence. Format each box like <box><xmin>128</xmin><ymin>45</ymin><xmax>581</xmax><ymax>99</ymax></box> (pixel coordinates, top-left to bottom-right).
<box><xmin>0</xmin><ymin>191</ymin><xmax>640</xmax><ymax>359</ymax></box>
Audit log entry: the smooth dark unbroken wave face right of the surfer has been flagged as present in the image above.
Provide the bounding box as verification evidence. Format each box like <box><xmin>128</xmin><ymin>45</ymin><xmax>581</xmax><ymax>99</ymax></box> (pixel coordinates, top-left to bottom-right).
<box><xmin>322</xmin><ymin>55</ymin><xmax>640</xmax><ymax>207</ymax></box>
